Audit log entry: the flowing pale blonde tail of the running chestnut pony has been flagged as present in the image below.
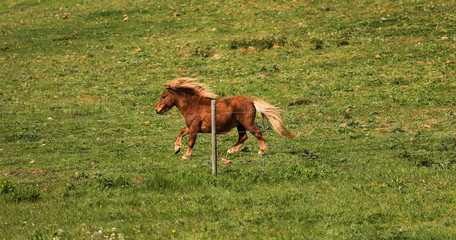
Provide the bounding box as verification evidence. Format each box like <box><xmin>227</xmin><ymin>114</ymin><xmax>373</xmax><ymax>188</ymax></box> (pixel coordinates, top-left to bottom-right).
<box><xmin>253</xmin><ymin>98</ymin><xmax>296</xmax><ymax>138</ymax></box>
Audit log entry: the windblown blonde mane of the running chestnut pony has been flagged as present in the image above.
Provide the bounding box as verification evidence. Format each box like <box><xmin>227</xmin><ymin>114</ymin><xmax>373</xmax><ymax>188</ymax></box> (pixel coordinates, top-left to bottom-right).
<box><xmin>165</xmin><ymin>77</ymin><xmax>217</xmax><ymax>99</ymax></box>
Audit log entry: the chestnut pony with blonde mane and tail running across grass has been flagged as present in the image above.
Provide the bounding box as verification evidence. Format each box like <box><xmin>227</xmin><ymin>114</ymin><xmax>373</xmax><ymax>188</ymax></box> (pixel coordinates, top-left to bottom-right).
<box><xmin>155</xmin><ymin>78</ymin><xmax>296</xmax><ymax>160</ymax></box>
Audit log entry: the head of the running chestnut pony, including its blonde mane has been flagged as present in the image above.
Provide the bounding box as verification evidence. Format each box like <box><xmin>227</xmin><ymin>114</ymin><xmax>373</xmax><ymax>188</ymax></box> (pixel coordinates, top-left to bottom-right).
<box><xmin>155</xmin><ymin>78</ymin><xmax>217</xmax><ymax>114</ymax></box>
